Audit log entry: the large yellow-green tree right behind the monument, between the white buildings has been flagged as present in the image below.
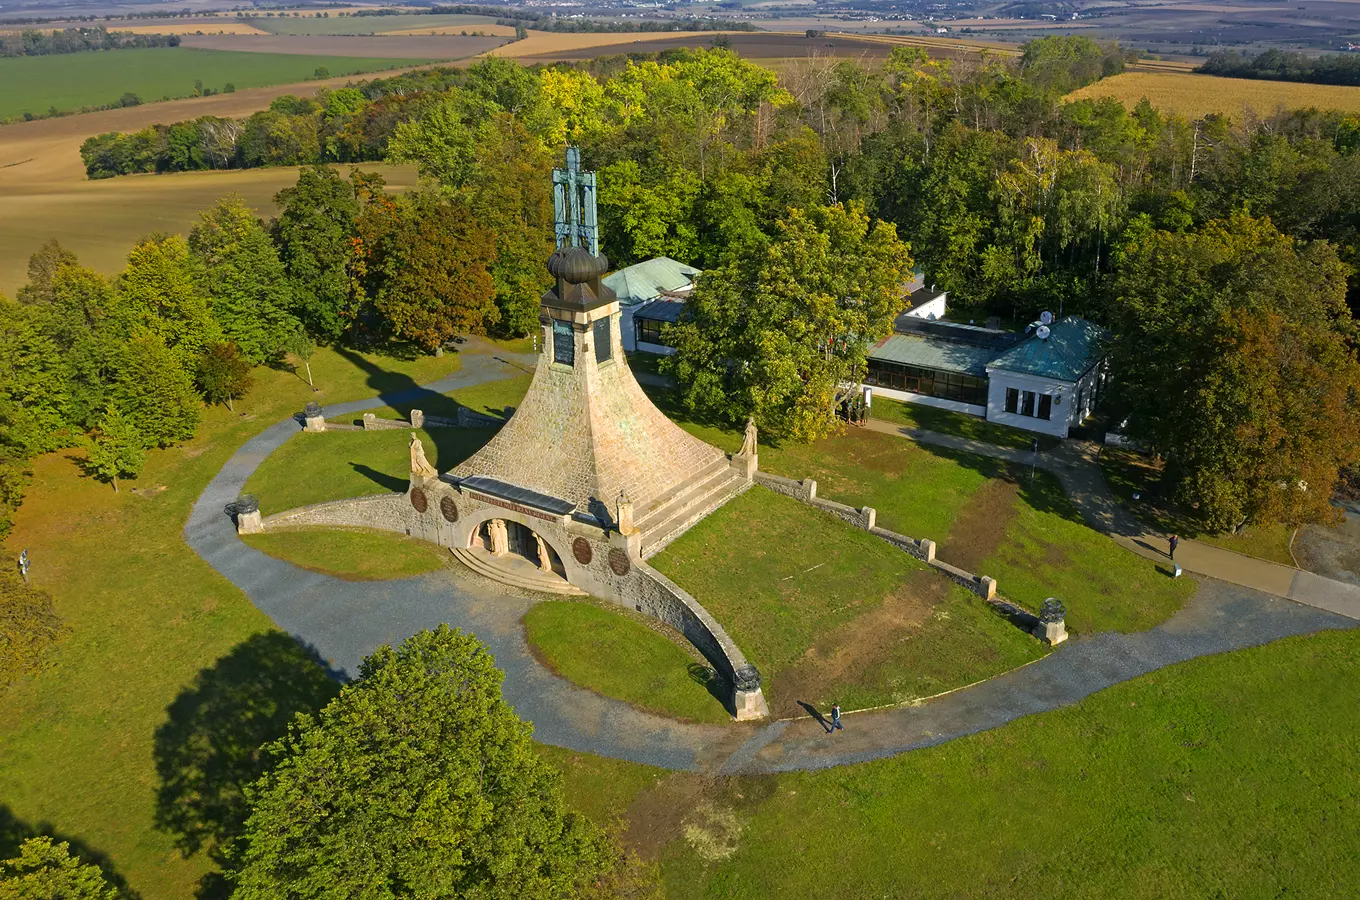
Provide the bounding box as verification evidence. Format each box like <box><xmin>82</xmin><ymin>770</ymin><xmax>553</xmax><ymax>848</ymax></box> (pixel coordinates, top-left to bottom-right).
<box><xmin>665</xmin><ymin>204</ymin><xmax>911</xmax><ymax>440</ymax></box>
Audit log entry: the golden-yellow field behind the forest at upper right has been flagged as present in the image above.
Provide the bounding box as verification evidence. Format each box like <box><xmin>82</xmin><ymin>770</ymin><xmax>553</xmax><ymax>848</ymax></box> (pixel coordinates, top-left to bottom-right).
<box><xmin>1068</xmin><ymin>72</ymin><xmax>1360</xmax><ymax>117</ymax></box>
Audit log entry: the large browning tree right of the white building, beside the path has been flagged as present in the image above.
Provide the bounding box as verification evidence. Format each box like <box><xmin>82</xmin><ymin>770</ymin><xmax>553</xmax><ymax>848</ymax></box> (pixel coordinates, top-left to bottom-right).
<box><xmin>1110</xmin><ymin>213</ymin><xmax>1360</xmax><ymax>529</ymax></box>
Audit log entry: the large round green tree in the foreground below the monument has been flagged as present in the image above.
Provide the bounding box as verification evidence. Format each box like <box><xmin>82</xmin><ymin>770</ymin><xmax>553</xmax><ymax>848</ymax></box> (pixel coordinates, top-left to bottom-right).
<box><xmin>231</xmin><ymin>625</ymin><xmax>616</xmax><ymax>900</ymax></box>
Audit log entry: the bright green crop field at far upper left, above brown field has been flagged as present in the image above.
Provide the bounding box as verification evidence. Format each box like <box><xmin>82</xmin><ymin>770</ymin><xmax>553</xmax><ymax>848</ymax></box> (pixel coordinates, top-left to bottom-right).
<box><xmin>0</xmin><ymin>48</ymin><xmax>426</xmax><ymax>121</ymax></box>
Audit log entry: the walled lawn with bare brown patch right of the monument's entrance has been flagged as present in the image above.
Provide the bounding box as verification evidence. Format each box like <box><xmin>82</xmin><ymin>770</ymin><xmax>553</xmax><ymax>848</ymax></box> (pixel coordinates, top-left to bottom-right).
<box><xmin>651</xmin><ymin>487</ymin><xmax>1046</xmax><ymax>715</ymax></box>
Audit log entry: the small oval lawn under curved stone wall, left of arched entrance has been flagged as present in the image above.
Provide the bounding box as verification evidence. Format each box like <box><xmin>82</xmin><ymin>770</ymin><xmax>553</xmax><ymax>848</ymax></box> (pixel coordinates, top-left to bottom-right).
<box><xmin>242</xmin><ymin>527</ymin><xmax>449</xmax><ymax>582</ymax></box>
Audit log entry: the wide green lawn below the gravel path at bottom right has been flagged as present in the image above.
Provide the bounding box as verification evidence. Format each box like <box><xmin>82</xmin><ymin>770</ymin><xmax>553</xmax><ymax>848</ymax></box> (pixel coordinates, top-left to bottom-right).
<box><xmin>544</xmin><ymin>631</ymin><xmax>1360</xmax><ymax>900</ymax></box>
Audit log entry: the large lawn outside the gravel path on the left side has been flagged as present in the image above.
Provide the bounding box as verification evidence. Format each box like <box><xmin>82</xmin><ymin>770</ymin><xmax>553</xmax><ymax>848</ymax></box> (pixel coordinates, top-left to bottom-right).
<box><xmin>0</xmin><ymin>342</ymin><xmax>460</xmax><ymax>900</ymax></box>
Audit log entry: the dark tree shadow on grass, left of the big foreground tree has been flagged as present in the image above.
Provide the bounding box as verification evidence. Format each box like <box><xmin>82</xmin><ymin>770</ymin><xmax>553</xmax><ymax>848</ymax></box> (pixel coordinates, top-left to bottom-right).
<box><xmin>152</xmin><ymin>631</ymin><xmax>340</xmax><ymax>875</ymax></box>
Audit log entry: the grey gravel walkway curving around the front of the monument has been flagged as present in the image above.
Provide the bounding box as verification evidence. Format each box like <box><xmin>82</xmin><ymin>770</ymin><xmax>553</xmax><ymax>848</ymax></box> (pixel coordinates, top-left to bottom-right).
<box><xmin>184</xmin><ymin>353</ymin><xmax>1357</xmax><ymax>774</ymax></box>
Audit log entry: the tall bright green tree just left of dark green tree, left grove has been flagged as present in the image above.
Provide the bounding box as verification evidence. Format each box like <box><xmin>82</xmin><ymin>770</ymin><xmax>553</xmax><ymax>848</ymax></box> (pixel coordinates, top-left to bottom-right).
<box><xmin>189</xmin><ymin>194</ymin><xmax>298</xmax><ymax>364</ymax></box>
